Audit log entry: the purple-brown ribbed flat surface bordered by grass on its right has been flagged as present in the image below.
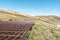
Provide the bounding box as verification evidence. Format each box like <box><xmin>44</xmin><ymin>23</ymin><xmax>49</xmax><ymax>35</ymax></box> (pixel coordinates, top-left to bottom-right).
<box><xmin>0</xmin><ymin>21</ymin><xmax>34</xmax><ymax>40</ymax></box>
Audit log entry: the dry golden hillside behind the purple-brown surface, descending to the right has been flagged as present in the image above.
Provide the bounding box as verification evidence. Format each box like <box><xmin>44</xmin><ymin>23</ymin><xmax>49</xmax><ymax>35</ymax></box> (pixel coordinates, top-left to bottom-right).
<box><xmin>0</xmin><ymin>9</ymin><xmax>32</xmax><ymax>21</ymax></box>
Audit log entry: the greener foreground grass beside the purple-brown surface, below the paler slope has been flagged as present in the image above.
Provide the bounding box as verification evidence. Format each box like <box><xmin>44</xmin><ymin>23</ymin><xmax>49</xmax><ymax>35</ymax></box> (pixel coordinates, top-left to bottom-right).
<box><xmin>25</xmin><ymin>20</ymin><xmax>60</xmax><ymax>40</ymax></box>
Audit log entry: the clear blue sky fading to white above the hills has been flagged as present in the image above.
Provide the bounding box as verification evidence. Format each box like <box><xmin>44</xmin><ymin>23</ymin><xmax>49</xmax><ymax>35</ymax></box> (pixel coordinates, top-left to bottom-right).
<box><xmin>0</xmin><ymin>0</ymin><xmax>60</xmax><ymax>16</ymax></box>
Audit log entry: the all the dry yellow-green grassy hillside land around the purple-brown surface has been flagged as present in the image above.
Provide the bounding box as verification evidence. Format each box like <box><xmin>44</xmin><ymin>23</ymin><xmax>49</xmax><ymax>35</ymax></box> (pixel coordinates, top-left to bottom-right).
<box><xmin>0</xmin><ymin>10</ymin><xmax>60</xmax><ymax>40</ymax></box>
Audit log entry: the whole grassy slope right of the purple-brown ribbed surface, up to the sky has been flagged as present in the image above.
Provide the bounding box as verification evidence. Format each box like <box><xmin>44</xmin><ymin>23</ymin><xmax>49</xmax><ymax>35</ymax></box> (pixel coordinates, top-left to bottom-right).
<box><xmin>26</xmin><ymin>16</ymin><xmax>60</xmax><ymax>40</ymax></box>
